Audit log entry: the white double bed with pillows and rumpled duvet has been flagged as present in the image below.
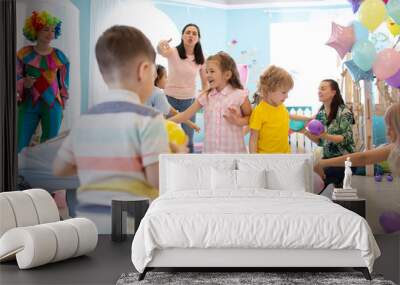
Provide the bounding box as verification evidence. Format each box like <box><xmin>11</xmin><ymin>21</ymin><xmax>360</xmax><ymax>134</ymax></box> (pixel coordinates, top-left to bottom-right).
<box><xmin>132</xmin><ymin>154</ymin><xmax>380</xmax><ymax>279</ymax></box>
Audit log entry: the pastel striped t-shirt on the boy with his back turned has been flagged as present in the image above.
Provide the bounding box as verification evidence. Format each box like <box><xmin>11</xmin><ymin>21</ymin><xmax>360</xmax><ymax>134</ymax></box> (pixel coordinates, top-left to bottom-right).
<box><xmin>58</xmin><ymin>90</ymin><xmax>169</xmax><ymax>195</ymax></box>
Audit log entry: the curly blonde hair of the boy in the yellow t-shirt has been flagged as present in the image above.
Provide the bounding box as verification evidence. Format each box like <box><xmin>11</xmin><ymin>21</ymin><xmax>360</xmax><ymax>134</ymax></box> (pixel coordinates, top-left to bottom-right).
<box><xmin>258</xmin><ymin>65</ymin><xmax>294</xmax><ymax>95</ymax></box>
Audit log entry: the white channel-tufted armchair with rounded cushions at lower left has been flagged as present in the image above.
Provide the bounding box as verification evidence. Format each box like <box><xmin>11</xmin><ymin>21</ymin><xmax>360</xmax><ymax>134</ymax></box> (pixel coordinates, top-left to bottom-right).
<box><xmin>0</xmin><ymin>189</ymin><xmax>97</xmax><ymax>269</ymax></box>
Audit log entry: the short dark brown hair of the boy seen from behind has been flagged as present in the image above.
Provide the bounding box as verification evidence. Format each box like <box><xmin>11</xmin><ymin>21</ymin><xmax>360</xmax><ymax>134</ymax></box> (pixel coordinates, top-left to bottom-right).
<box><xmin>95</xmin><ymin>26</ymin><xmax>156</xmax><ymax>75</ymax></box>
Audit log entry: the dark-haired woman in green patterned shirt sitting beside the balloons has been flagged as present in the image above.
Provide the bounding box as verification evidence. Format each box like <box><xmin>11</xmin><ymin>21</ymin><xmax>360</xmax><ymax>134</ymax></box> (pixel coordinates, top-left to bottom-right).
<box><xmin>300</xmin><ymin>79</ymin><xmax>355</xmax><ymax>187</ymax></box>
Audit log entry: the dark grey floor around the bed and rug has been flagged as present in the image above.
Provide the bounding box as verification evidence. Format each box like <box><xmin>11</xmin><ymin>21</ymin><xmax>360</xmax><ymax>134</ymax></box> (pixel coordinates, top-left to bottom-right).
<box><xmin>0</xmin><ymin>235</ymin><xmax>400</xmax><ymax>285</ymax></box>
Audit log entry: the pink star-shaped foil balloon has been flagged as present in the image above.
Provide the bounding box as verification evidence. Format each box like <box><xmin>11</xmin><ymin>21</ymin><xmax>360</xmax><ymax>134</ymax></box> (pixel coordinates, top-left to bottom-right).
<box><xmin>326</xmin><ymin>22</ymin><xmax>355</xmax><ymax>59</ymax></box>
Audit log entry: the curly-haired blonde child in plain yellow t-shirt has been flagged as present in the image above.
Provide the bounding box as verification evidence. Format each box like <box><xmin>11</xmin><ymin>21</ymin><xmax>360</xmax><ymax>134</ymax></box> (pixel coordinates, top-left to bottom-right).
<box><xmin>249</xmin><ymin>65</ymin><xmax>302</xmax><ymax>153</ymax></box>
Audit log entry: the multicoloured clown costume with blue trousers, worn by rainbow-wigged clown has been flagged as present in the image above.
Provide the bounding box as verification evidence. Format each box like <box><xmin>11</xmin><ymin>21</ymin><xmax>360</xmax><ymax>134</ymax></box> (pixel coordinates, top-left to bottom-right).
<box><xmin>17</xmin><ymin>46</ymin><xmax>69</xmax><ymax>152</ymax></box>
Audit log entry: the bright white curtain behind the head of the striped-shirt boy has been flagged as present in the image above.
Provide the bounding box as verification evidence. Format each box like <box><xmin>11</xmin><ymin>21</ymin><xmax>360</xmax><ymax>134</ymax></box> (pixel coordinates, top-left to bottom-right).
<box><xmin>88</xmin><ymin>0</ymin><xmax>180</xmax><ymax>108</ymax></box>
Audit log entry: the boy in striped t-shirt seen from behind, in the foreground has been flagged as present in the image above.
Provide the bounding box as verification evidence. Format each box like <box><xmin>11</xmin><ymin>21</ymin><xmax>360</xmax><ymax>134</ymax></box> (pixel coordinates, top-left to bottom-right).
<box><xmin>53</xmin><ymin>26</ymin><xmax>169</xmax><ymax>198</ymax></box>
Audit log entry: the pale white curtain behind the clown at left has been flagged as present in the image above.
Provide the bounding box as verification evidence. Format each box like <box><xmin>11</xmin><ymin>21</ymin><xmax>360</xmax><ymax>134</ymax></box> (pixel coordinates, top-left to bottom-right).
<box><xmin>16</xmin><ymin>0</ymin><xmax>81</xmax><ymax>131</ymax></box>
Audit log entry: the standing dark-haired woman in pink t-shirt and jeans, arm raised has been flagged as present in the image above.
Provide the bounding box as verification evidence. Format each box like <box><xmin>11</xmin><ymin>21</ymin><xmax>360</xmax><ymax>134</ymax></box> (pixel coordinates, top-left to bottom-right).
<box><xmin>157</xmin><ymin>24</ymin><xmax>208</xmax><ymax>152</ymax></box>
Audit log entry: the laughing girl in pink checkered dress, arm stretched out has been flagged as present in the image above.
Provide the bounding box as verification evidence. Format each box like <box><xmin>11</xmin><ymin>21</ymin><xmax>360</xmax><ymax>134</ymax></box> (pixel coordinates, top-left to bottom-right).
<box><xmin>170</xmin><ymin>52</ymin><xmax>251</xmax><ymax>153</ymax></box>
